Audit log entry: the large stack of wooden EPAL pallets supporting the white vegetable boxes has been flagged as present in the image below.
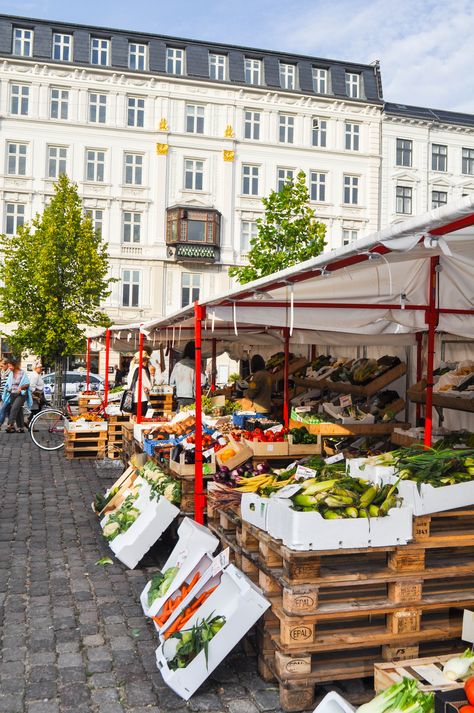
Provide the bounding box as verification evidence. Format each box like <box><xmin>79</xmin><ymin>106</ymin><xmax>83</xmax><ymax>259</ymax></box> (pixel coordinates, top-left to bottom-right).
<box><xmin>210</xmin><ymin>507</ymin><xmax>474</xmax><ymax>711</ymax></box>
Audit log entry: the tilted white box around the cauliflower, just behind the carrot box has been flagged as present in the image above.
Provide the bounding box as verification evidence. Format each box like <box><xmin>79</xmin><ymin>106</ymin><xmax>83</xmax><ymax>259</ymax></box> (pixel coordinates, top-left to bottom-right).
<box><xmin>140</xmin><ymin>517</ymin><xmax>219</xmax><ymax>616</ymax></box>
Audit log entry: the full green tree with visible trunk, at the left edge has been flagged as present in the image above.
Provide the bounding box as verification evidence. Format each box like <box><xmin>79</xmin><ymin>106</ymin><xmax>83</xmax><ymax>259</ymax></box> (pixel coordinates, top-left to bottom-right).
<box><xmin>0</xmin><ymin>175</ymin><xmax>112</xmax><ymax>401</ymax></box>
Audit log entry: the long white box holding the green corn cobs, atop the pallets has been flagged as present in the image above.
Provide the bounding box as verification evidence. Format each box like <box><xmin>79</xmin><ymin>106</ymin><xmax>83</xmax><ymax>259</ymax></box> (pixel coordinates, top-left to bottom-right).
<box><xmin>267</xmin><ymin>498</ymin><xmax>413</xmax><ymax>550</ymax></box>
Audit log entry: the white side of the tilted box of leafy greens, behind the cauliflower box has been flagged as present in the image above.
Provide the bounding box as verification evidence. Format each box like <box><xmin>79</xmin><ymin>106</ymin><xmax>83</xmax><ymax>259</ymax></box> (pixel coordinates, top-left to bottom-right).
<box><xmin>109</xmin><ymin>496</ymin><xmax>180</xmax><ymax>569</ymax></box>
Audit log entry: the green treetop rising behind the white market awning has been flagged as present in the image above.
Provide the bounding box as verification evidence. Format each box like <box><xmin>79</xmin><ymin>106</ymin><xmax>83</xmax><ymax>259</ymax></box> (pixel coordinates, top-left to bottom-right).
<box><xmin>229</xmin><ymin>171</ymin><xmax>326</xmax><ymax>284</ymax></box>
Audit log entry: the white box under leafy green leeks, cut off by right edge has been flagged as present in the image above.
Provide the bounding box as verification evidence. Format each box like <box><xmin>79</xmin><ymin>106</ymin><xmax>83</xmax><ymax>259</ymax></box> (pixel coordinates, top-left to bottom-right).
<box><xmin>385</xmin><ymin>475</ymin><xmax>474</xmax><ymax>515</ymax></box>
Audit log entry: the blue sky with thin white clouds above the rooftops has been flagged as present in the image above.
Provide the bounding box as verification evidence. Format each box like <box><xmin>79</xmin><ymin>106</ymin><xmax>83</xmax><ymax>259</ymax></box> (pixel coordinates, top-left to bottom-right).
<box><xmin>0</xmin><ymin>0</ymin><xmax>474</xmax><ymax>113</ymax></box>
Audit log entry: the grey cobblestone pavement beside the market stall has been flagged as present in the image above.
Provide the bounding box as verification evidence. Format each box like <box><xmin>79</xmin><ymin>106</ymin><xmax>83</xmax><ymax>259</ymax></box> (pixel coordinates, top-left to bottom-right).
<box><xmin>0</xmin><ymin>432</ymin><xmax>288</xmax><ymax>713</ymax></box>
